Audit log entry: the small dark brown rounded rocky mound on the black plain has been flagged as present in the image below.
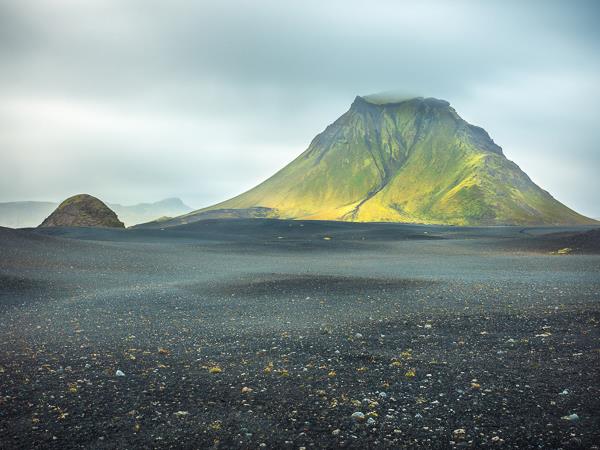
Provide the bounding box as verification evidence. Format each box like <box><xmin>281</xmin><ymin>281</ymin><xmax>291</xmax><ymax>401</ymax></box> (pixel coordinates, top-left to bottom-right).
<box><xmin>40</xmin><ymin>194</ymin><xmax>125</xmax><ymax>228</ymax></box>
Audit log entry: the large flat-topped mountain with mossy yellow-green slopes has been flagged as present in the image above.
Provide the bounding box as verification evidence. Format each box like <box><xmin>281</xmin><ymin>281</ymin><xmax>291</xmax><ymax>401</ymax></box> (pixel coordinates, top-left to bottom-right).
<box><xmin>155</xmin><ymin>97</ymin><xmax>596</xmax><ymax>226</ymax></box>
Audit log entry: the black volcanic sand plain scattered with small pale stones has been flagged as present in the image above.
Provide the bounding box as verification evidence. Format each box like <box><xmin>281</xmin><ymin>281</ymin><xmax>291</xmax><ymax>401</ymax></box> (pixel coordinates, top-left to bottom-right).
<box><xmin>0</xmin><ymin>220</ymin><xmax>600</xmax><ymax>449</ymax></box>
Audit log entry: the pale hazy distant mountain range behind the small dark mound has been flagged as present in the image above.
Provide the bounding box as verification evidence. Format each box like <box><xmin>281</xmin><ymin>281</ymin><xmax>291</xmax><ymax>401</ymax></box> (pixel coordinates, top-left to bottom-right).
<box><xmin>0</xmin><ymin>198</ymin><xmax>192</xmax><ymax>228</ymax></box>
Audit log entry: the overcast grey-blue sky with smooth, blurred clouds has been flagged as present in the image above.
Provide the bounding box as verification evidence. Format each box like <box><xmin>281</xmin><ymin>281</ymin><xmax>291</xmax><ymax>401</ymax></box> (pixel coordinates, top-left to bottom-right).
<box><xmin>0</xmin><ymin>0</ymin><xmax>600</xmax><ymax>217</ymax></box>
